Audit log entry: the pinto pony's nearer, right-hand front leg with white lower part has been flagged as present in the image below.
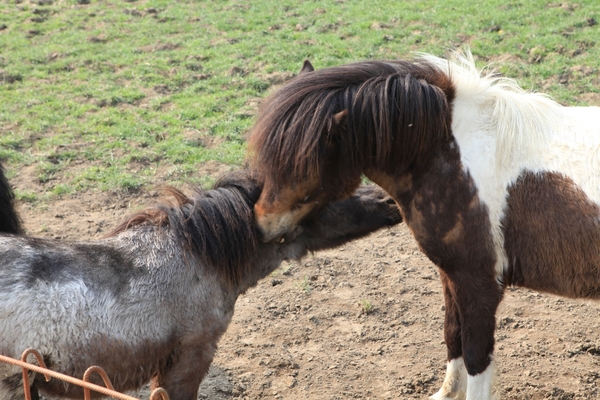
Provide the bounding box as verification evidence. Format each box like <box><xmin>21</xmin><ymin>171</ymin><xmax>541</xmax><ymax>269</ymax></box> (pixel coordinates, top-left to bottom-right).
<box><xmin>446</xmin><ymin>269</ymin><xmax>502</xmax><ymax>400</ymax></box>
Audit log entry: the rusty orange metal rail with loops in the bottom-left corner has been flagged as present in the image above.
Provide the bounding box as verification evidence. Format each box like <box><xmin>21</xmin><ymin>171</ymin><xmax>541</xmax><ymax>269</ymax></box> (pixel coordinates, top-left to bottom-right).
<box><xmin>0</xmin><ymin>349</ymin><xmax>169</xmax><ymax>400</ymax></box>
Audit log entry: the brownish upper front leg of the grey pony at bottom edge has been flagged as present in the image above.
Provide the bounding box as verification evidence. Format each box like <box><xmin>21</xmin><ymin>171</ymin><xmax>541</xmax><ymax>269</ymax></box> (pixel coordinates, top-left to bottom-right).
<box><xmin>151</xmin><ymin>343</ymin><xmax>216</xmax><ymax>400</ymax></box>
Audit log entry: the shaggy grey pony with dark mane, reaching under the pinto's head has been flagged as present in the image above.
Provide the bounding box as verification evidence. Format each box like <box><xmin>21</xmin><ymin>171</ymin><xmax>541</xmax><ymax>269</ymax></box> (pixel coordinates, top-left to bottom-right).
<box><xmin>0</xmin><ymin>172</ymin><xmax>401</xmax><ymax>400</ymax></box>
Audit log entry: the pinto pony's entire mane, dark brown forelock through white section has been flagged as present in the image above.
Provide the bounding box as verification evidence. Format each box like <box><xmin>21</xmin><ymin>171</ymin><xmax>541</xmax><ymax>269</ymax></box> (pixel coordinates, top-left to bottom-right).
<box><xmin>250</xmin><ymin>50</ymin><xmax>564</xmax><ymax>179</ymax></box>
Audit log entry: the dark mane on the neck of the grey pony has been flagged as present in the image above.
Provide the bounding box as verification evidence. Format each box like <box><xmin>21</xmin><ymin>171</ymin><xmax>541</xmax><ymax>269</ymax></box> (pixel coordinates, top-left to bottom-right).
<box><xmin>108</xmin><ymin>172</ymin><xmax>262</xmax><ymax>285</ymax></box>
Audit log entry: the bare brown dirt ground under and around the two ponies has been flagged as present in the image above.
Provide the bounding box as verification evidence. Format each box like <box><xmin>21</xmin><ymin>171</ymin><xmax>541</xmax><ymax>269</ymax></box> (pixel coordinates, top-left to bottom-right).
<box><xmin>13</xmin><ymin>162</ymin><xmax>600</xmax><ymax>400</ymax></box>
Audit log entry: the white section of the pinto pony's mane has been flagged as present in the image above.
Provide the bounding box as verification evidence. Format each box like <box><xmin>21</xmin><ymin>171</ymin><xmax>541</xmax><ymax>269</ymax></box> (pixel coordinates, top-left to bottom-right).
<box><xmin>421</xmin><ymin>49</ymin><xmax>564</xmax><ymax>163</ymax></box>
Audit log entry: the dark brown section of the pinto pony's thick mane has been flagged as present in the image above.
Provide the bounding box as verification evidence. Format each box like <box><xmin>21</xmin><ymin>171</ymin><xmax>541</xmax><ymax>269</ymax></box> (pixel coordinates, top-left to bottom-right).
<box><xmin>249</xmin><ymin>59</ymin><xmax>454</xmax><ymax>183</ymax></box>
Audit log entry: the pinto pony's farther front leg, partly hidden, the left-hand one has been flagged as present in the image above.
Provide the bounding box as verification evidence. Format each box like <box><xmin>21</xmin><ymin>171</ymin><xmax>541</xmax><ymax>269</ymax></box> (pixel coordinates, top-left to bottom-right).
<box><xmin>429</xmin><ymin>270</ymin><xmax>467</xmax><ymax>400</ymax></box>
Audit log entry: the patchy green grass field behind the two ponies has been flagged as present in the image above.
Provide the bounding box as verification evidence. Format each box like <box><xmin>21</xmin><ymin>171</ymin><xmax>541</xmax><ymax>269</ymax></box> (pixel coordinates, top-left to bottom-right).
<box><xmin>0</xmin><ymin>0</ymin><xmax>600</xmax><ymax>195</ymax></box>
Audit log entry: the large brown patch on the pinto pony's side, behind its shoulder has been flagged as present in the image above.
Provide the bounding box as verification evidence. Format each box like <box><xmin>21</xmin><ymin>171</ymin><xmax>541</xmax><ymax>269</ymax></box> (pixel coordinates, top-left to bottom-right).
<box><xmin>502</xmin><ymin>171</ymin><xmax>600</xmax><ymax>298</ymax></box>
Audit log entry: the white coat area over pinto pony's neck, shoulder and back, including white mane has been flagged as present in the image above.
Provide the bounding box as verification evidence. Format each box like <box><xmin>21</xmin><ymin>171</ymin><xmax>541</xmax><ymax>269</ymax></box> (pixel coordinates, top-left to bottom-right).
<box><xmin>424</xmin><ymin>53</ymin><xmax>600</xmax><ymax>281</ymax></box>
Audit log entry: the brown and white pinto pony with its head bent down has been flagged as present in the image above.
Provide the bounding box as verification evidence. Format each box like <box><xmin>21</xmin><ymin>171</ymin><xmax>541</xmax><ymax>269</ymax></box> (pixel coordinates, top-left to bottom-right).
<box><xmin>250</xmin><ymin>53</ymin><xmax>600</xmax><ymax>400</ymax></box>
